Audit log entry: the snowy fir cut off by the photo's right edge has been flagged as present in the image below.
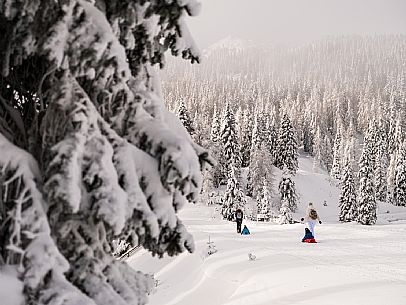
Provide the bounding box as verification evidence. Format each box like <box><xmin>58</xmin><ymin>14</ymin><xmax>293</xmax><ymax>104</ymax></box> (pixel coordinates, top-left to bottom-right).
<box><xmin>393</xmin><ymin>141</ymin><xmax>406</xmax><ymax>206</ymax></box>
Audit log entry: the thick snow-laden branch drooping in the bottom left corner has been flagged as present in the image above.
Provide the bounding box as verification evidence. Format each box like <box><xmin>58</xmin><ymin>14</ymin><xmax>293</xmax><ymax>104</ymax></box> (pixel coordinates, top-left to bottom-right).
<box><xmin>0</xmin><ymin>133</ymin><xmax>95</xmax><ymax>305</ymax></box>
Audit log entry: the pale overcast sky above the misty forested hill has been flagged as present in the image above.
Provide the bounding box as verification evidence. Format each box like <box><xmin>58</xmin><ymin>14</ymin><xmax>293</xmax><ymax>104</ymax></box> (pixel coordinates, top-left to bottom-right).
<box><xmin>188</xmin><ymin>0</ymin><xmax>406</xmax><ymax>48</ymax></box>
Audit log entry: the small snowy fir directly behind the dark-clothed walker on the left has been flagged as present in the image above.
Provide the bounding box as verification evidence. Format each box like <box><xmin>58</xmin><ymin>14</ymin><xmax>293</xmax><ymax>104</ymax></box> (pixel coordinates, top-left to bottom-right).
<box><xmin>221</xmin><ymin>166</ymin><xmax>246</xmax><ymax>220</ymax></box>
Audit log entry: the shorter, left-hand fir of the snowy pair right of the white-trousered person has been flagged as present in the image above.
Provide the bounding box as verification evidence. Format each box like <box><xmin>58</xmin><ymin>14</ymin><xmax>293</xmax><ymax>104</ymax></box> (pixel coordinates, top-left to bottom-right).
<box><xmin>339</xmin><ymin>155</ymin><xmax>357</xmax><ymax>222</ymax></box>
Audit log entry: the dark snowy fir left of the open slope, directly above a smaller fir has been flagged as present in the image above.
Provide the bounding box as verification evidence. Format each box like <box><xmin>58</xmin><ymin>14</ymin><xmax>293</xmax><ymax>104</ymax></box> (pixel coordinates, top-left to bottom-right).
<box><xmin>276</xmin><ymin>114</ymin><xmax>298</xmax><ymax>174</ymax></box>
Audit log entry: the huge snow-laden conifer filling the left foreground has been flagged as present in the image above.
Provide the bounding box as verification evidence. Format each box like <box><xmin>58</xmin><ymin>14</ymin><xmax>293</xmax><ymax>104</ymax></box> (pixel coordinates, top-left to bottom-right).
<box><xmin>0</xmin><ymin>0</ymin><xmax>212</xmax><ymax>305</ymax></box>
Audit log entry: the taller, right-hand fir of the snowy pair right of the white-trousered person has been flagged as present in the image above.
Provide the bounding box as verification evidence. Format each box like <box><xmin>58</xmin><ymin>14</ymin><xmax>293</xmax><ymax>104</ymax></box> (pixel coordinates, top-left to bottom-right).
<box><xmin>357</xmin><ymin>138</ymin><xmax>376</xmax><ymax>225</ymax></box>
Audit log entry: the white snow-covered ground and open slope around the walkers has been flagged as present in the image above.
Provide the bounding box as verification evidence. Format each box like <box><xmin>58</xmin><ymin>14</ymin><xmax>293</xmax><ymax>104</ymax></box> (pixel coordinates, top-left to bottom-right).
<box><xmin>128</xmin><ymin>156</ymin><xmax>406</xmax><ymax>305</ymax></box>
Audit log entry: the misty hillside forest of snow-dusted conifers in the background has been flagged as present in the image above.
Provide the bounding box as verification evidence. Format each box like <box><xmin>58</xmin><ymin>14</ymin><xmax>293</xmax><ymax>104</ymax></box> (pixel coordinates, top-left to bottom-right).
<box><xmin>163</xmin><ymin>35</ymin><xmax>406</xmax><ymax>224</ymax></box>
